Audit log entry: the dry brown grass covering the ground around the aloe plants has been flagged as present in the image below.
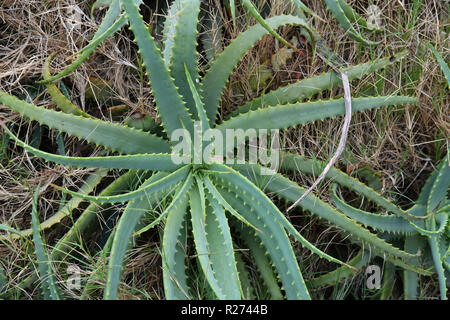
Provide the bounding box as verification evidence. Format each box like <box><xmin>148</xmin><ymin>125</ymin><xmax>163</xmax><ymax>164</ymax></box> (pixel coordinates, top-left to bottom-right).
<box><xmin>0</xmin><ymin>0</ymin><xmax>450</xmax><ymax>299</ymax></box>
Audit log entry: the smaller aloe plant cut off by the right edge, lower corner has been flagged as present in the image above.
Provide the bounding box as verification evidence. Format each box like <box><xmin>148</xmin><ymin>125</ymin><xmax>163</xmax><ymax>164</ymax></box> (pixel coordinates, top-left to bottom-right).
<box><xmin>331</xmin><ymin>157</ymin><xmax>450</xmax><ymax>299</ymax></box>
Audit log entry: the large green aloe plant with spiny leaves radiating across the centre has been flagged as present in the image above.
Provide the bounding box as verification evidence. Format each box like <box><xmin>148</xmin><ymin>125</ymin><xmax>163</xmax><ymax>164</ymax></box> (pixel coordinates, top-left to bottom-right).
<box><xmin>0</xmin><ymin>0</ymin><xmax>440</xmax><ymax>299</ymax></box>
